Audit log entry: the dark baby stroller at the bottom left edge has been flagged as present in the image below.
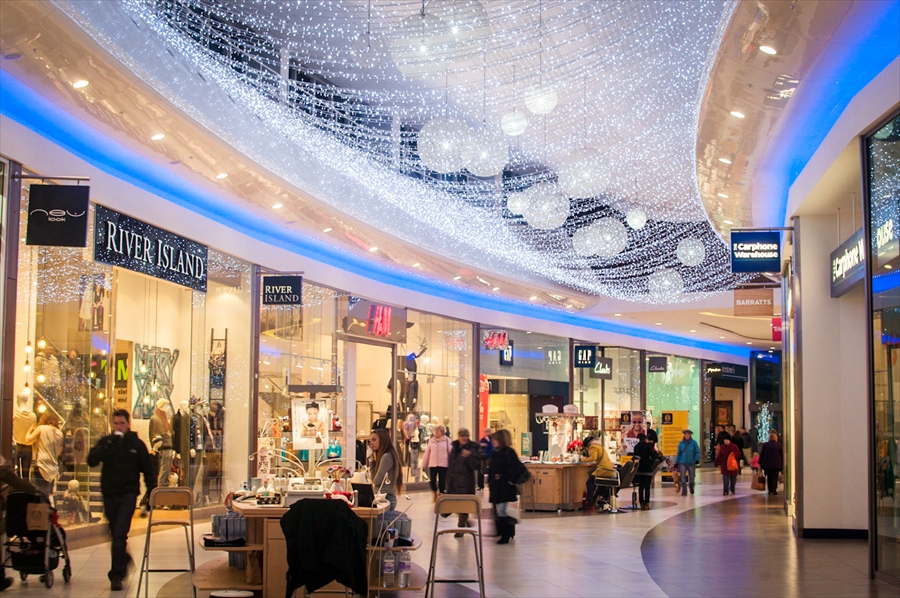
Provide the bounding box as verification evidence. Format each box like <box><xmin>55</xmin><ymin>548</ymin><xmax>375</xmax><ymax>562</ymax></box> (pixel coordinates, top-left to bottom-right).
<box><xmin>3</xmin><ymin>492</ymin><xmax>72</xmax><ymax>588</ymax></box>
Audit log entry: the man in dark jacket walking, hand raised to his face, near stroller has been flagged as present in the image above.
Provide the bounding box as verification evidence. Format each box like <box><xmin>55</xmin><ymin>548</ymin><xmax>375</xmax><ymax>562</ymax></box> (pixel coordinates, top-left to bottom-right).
<box><xmin>88</xmin><ymin>409</ymin><xmax>156</xmax><ymax>591</ymax></box>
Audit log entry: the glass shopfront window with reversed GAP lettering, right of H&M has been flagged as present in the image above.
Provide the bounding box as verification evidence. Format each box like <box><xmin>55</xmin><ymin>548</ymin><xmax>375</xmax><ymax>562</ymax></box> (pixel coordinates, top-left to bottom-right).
<box><xmin>480</xmin><ymin>327</ymin><xmax>569</xmax><ymax>455</ymax></box>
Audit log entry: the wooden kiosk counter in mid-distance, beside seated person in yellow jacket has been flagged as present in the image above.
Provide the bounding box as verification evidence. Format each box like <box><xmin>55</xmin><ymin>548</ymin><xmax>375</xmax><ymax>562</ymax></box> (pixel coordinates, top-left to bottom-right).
<box><xmin>521</xmin><ymin>463</ymin><xmax>595</xmax><ymax>511</ymax></box>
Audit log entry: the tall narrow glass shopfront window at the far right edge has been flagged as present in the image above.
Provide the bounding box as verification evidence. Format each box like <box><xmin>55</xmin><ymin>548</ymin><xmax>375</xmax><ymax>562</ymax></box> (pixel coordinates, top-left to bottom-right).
<box><xmin>866</xmin><ymin>111</ymin><xmax>900</xmax><ymax>581</ymax></box>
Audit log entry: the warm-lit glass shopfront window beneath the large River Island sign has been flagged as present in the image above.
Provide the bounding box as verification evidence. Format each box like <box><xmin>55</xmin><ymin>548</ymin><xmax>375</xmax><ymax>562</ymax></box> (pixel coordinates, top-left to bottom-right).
<box><xmin>13</xmin><ymin>185</ymin><xmax>251</xmax><ymax>526</ymax></box>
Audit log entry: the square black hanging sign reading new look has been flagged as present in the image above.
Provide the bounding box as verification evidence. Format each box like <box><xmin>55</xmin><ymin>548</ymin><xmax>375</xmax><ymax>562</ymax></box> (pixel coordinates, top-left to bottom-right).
<box><xmin>25</xmin><ymin>185</ymin><xmax>91</xmax><ymax>247</ymax></box>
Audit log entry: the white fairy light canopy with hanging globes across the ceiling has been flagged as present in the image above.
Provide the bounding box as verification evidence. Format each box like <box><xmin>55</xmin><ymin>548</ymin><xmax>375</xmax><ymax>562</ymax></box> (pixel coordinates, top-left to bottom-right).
<box><xmin>56</xmin><ymin>0</ymin><xmax>738</xmax><ymax>303</ymax></box>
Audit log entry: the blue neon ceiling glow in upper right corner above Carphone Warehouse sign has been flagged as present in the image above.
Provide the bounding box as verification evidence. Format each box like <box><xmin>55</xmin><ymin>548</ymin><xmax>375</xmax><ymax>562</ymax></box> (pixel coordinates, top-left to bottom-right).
<box><xmin>764</xmin><ymin>0</ymin><xmax>900</xmax><ymax>226</ymax></box>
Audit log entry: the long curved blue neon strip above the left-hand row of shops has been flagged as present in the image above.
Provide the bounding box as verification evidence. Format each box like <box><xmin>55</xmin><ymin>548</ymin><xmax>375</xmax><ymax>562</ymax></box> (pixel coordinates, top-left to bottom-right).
<box><xmin>0</xmin><ymin>69</ymin><xmax>749</xmax><ymax>358</ymax></box>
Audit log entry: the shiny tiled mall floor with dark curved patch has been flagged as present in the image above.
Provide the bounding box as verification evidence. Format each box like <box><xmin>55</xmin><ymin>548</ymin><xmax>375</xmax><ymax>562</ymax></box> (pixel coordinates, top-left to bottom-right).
<box><xmin>6</xmin><ymin>471</ymin><xmax>898</xmax><ymax>598</ymax></box>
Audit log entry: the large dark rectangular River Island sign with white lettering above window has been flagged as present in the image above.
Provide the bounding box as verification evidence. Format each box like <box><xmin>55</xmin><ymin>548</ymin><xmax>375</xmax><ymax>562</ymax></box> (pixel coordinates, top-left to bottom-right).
<box><xmin>94</xmin><ymin>206</ymin><xmax>207</xmax><ymax>292</ymax></box>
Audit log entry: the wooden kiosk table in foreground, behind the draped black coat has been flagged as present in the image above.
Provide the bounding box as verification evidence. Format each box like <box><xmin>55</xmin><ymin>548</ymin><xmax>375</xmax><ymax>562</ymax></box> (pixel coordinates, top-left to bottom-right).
<box><xmin>193</xmin><ymin>501</ymin><xmax>384</xmax><ymax>598</ymax></box>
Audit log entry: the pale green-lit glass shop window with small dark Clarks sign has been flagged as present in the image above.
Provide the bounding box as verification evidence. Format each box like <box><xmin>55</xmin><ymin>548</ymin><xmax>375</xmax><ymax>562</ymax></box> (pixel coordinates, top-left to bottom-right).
<box><xmin>646</xmin><ymin>355</ymin><xmax>701</xmax><ymax>458</ymax></box>
